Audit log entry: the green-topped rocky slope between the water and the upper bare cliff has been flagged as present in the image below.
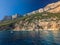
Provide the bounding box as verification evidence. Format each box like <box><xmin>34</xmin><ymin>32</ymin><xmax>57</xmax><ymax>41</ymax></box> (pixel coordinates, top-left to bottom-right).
<box><xmin>0</xmin><ymin>12</ymin><xmax>60</xmax><ymax>31</ymax></box>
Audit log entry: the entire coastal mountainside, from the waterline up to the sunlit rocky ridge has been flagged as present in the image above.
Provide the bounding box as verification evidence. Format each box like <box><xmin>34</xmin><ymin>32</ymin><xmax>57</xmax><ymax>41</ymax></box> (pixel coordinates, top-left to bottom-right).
<box><xmin>0</xmin><ymin>1</ymin><xmax>60</xmax><ymax>31</ymax></box>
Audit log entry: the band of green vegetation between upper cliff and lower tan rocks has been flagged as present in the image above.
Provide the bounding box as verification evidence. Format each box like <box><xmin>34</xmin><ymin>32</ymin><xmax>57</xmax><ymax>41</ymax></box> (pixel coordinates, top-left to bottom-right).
<box><xmin>0</xmin><ymin>12</ymin><xmax>60</xmax><ymax>27</ymax></box>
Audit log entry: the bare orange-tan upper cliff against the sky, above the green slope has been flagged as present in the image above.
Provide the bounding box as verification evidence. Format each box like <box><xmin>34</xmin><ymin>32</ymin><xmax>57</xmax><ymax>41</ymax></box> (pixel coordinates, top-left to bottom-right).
<box><xmin>39</xmin><ymin>1</ymin><xmax>60</xmax><ymax>13</ymax></box>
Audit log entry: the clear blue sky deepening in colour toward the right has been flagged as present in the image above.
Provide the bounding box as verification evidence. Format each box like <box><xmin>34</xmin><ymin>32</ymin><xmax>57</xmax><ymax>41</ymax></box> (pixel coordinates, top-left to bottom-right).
<box><xmin>0</xmin><ymin>0</ymin><xmax>58</xmax><ymax>20</ymax></box>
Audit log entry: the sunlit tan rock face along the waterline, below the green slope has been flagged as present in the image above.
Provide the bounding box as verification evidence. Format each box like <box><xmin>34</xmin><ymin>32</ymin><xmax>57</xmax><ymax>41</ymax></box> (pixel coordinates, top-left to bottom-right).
<box><xmin>14</xmin><ymin>20</ymin><xmax>60</xmax><ymax>31</ymax></box>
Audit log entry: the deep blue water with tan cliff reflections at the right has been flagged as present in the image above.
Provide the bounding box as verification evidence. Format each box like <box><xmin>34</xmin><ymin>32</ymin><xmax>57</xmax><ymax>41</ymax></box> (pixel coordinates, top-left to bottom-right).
<box><xmin>0</xmin><ymin>30</ymin><xmax>60</xmax><ymax>45</ymax></box>
